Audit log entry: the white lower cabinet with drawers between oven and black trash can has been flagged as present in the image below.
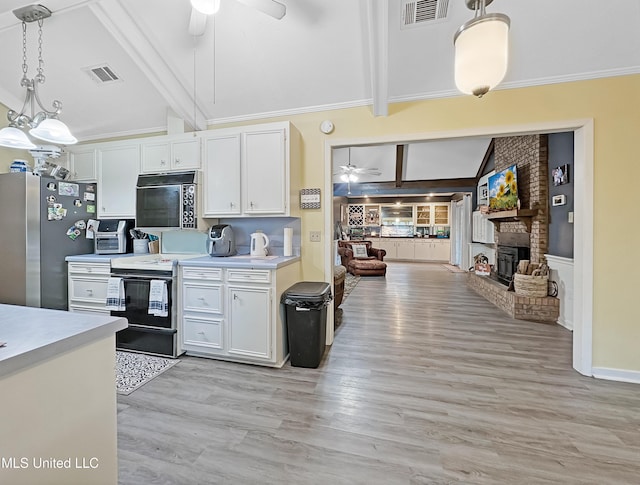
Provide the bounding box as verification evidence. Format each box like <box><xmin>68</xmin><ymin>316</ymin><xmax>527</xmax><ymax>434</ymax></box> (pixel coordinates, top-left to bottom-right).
<box><xmin>178</xmin><ymin>262</ymin><xmax>300</xmax><ymax>367</ymax></box>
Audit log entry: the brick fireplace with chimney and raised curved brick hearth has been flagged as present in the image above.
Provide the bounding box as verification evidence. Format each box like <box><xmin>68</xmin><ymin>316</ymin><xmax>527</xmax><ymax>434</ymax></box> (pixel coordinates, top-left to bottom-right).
<box><xmin>468</xmin><ymin>135</ymin><xmax>560</xmax><ymax>322</ymax></box>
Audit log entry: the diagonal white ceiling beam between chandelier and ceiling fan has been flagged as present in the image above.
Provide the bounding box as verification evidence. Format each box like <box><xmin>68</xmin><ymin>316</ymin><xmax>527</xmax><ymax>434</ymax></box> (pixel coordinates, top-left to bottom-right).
<box><xmin>89</xmin><ymin>0</ymin><xmax>207</xmax><ymax>130</ymax></box>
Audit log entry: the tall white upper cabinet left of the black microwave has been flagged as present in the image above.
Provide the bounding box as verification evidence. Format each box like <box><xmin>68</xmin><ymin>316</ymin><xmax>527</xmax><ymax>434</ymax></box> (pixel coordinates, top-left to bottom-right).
<box><xmin>98</xmin><ymin>142</ymin><xmax>140</xmax><ymax>219</ymax></box>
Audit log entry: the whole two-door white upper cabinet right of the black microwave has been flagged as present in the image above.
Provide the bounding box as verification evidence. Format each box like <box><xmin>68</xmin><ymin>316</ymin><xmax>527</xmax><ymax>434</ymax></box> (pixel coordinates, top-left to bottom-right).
<box><xmin>203</xmin><ymin>122</ymin><xmax>299</xmax><ymax>217</ymax></box>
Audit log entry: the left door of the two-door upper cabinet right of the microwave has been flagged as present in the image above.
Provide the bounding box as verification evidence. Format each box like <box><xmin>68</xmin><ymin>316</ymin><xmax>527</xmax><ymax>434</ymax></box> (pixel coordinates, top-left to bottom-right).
<box><xmin>202</xmin><ymin>133</ymin><xmax>242</xmax><ymax>217</ymax></box>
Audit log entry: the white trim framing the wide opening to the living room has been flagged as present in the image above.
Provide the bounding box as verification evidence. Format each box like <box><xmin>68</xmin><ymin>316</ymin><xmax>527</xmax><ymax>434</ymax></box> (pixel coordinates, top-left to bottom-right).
<box><xmin>324</xmin><ymin>118</ymin><xmax>594</xmax><ymax>376</ymax></box>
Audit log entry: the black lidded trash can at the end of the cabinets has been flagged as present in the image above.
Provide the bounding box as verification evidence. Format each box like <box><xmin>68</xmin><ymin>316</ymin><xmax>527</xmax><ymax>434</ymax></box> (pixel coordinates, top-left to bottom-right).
<box><xmin>280</xmin><ymin>281</ymin><xmax>331</xmax><ymax>368</ymax></box>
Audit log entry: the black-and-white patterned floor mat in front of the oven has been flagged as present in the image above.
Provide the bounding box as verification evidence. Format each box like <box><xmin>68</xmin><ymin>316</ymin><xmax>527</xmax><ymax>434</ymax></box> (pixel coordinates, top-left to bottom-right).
<box><xmin>116</xmin><ymin>350</ymin><xmax>179</xmax><ymax>396</ymax></box>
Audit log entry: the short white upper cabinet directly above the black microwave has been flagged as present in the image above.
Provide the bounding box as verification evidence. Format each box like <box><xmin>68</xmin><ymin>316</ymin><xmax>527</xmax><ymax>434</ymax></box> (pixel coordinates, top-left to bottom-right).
<box><xmin>142</xmin><ymin>133</ymin><xmax>200</xmax><ymax>173</ymax></box>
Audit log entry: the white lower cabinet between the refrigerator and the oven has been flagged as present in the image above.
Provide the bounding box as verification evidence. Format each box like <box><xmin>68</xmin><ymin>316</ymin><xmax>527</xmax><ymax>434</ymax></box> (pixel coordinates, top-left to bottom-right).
<box><xmin>67</xmin><ymin>262</ymin><xmax>111</xmax><ymax>315</ymax></box>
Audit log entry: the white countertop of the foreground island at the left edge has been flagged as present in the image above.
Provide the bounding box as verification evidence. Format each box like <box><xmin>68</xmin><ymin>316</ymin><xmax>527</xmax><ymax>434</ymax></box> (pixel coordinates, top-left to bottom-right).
<box><xmin>0</xmin><ymin>304</ymin><xmax>127</xmax><ymax>377</ymax></box>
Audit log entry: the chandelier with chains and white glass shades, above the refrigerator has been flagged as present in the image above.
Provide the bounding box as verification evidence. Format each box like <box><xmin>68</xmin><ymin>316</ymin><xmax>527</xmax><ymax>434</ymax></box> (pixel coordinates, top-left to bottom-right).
<box><xmin>0</xmin><ymin>5</ymin><xmax>78</xmax><ymax>150</ymax></box>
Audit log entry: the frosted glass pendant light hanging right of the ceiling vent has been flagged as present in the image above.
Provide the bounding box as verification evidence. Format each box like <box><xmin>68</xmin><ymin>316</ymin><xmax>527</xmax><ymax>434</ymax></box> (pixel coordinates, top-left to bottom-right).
<box><xmin>453</xmin><ymin>0</ymin><xmax>510</xmax><ymax>97</ymax></box>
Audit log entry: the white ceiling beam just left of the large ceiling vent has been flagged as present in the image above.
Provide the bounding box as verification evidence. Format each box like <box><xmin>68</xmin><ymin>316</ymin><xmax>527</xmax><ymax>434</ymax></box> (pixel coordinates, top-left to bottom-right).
<box><xmin>366</xmin><ymin>0</ymin><xmax>389</xmax><ymax>116</ymax></box>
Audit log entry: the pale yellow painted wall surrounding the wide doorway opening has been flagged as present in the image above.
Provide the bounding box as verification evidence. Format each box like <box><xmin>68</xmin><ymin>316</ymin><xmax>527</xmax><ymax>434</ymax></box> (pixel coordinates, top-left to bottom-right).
<box><xmin>212</xmin><ymin>75</ymin><xmax>640</xmax><ymax>371</ymax></box>
